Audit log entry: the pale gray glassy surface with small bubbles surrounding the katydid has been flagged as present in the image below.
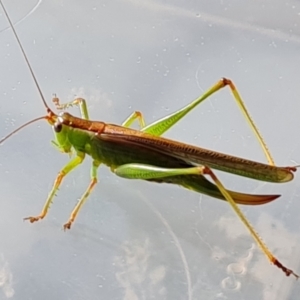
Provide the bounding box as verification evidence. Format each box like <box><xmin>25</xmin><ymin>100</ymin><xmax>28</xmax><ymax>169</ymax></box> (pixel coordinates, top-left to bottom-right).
<box><xmin>0</xmin><ymin>0</ymin><xmax>300</xmax><ymax>300</ymax></box>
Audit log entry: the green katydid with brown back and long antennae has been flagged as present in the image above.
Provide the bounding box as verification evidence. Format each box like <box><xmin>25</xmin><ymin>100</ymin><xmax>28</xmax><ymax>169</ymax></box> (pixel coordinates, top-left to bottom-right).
<box><xmin>0</xmin><ymin>1</ymin><xmax>299</xmax><ymax>278</ymax></box>
